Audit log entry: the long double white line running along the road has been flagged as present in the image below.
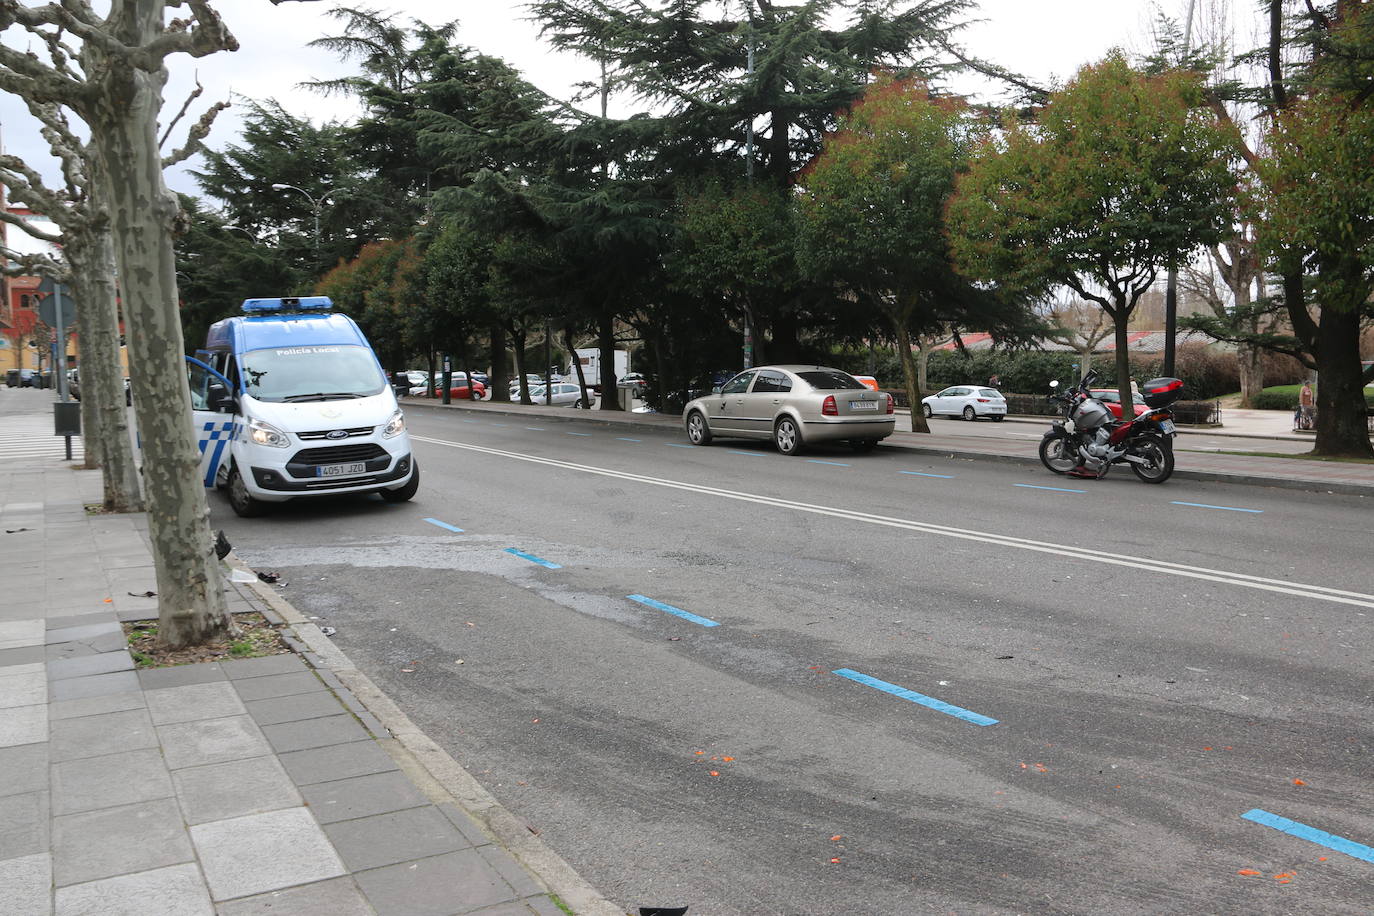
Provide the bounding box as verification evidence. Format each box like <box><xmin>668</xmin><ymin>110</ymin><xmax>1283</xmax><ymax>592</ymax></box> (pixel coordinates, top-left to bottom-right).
<box><xmin>411</xmin><ymin>435</ymin><xmax>1374</xmax><ymax>607</ymax></box>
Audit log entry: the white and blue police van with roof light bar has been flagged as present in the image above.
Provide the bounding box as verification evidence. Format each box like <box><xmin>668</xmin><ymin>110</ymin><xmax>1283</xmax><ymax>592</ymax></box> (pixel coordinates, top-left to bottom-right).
<box><xmin>185</xmin><ymin>295</ymin><xmax>420</xmax><ymax>516</ymax></box>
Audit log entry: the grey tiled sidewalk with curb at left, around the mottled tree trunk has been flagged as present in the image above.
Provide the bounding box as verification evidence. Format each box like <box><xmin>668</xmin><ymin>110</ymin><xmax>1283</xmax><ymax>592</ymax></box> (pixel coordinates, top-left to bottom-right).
<box><xmin>0</xmin><ymin>420</ymin><xmax>622</xmax><ymax>916</ymax></box>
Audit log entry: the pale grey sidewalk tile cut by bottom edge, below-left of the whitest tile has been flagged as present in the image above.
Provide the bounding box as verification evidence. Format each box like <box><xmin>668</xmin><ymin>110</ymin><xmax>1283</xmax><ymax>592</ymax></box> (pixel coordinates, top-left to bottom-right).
<box><xmin>55</xmin><ymin>862</ymin><xmax>214</xmax><ymax>916</ymax></box>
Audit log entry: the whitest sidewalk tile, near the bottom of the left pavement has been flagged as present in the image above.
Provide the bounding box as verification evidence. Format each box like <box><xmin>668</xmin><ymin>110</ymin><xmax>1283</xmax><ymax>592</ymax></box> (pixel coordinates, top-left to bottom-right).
<box><xmin>191</xmin><ymin>808</ymin><xmax>346</xmax><ymax>901</ymax></box>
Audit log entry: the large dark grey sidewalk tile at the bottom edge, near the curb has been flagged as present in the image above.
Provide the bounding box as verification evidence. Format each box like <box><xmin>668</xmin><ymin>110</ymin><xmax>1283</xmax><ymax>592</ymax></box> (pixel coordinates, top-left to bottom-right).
<box><xmin>353</xmin><ymin>849</ymin><xmax>518</xmax><ymax>916</ymax></box>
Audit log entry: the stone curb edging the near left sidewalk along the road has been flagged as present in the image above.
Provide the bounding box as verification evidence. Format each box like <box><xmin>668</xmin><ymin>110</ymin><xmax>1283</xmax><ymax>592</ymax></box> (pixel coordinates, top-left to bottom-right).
<box><xmin>224</xmin><ymin>551</ymin><xmax>625</xmax><ymax>916</ymax></box>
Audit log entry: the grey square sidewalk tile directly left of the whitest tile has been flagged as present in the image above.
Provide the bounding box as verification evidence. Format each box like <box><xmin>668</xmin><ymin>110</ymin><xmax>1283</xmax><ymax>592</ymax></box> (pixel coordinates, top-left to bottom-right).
<box><xmin>52</xmin><ymin>798</ymin><xmax>195</xmax><ymax>887</ymax></box>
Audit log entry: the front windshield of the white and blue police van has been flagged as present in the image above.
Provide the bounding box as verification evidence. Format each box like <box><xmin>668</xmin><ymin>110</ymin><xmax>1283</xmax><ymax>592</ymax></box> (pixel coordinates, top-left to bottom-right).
<box><xmin>240</xmin><ymin>345</ymin><xmax>386</xmax><ymax>401</ymax></box>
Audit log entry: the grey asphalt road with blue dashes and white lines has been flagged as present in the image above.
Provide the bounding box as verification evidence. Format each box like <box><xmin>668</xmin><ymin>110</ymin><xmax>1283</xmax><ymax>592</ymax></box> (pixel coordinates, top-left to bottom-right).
<box><xmin>210</xmin><ymin>411</ymin><xmax>1374</xmax><ymax>916</ymax></box>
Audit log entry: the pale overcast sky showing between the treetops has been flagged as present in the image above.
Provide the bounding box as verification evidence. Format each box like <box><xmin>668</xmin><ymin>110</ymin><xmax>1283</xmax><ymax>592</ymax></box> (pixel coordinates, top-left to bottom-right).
<box><xmin>0</xmin><ymin>0</ymin><xmax>1187</xmax><ymax>204</ymax></box>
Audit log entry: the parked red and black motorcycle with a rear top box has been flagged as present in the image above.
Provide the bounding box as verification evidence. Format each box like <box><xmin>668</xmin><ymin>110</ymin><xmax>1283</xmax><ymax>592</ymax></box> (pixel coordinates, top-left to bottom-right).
<box><xmin>1040</xmin><ymin>369</ymin><xmax>1183</xmax><ymax>483</ymax></box>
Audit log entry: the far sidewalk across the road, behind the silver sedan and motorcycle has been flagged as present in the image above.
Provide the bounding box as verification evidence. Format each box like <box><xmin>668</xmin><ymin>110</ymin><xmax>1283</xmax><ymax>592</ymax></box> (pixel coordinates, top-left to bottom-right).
<box><xmin>404</xmin><ymin>398</ymin><xmax>1374</xmax><ymax>497</ymax></box>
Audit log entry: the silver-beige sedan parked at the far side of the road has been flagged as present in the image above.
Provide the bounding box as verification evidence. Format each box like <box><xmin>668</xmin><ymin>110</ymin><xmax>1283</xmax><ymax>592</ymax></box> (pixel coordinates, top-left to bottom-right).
<box><xmin>683</xmin><ymin>365</ymin><xmax>896</xmax><ymax>455</ymax></box>
